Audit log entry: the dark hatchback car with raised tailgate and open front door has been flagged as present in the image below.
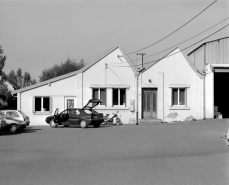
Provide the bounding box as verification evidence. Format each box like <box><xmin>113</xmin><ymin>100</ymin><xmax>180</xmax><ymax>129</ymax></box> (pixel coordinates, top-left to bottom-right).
<box><xmin>45</xmin><ymin>99</ymin><xmax>104</xmax><ymax>128</ymax></box>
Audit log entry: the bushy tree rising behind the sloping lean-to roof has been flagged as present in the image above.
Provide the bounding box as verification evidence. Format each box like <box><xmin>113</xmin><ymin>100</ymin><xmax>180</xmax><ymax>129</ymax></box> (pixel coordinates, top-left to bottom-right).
<box><xmin>39</xmin><ymin>57</ymin><xmax>85</xmax><ymax>82</ymax></box>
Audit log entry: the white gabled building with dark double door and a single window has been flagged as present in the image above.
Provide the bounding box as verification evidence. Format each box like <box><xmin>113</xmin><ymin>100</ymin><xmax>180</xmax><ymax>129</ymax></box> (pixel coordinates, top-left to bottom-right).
<box><xmin>138</xmin><ymin>48</ymin><xmax>203</xmax><ymax>122</ymax></box>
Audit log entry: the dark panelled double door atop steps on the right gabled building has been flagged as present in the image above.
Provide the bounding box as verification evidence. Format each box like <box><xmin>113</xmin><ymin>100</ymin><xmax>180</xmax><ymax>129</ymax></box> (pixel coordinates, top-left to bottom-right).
<box><xmin>142</xmin><ymin>88</ymin><xmax>157</xmax><ymax>119</ymax></box>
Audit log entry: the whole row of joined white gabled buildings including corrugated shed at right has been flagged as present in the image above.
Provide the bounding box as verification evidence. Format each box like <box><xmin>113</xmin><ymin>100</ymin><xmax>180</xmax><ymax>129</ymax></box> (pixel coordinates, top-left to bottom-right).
<box><xmin>12</xmin><ymin>37</ymin><xmax>229</xmax><ymax>125</ymax></box>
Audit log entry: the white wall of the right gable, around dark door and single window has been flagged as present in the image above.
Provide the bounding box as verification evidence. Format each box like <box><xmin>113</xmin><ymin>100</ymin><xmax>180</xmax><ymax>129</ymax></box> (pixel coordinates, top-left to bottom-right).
<box><xmin>139</xmin><ymin>49</ymin><xmax>203</xmax><ymax>122</ymax></box>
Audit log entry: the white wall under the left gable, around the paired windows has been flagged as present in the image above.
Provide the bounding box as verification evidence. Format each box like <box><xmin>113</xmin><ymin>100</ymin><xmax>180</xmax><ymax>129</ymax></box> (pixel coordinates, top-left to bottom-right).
<box><xmin>83</xmin><ymin>48</ymin><xmax>134</xmax><ymax>124</ymax></box>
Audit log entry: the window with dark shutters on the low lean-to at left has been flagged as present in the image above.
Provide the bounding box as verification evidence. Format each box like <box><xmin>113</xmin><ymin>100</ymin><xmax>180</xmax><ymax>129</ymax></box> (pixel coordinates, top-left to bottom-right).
<box><xmin>33</xmin><ymin>97</ymin><xmax>51</xmax><ymax>112</ymax></box>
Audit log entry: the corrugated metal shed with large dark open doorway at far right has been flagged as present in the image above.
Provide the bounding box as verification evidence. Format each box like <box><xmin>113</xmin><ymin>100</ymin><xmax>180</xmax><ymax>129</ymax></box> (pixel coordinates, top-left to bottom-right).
<box><xmin>188</xmin><ymin>37</ymin><xmax>229</xmax><ymax>118</ymax></box>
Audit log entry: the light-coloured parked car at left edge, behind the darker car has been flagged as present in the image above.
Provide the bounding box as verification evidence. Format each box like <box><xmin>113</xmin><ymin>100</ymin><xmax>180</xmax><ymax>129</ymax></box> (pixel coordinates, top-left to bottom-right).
<box><xmin>0</xmin><ymin>110</ymin><xmax>30</xmax><ymax>126</ymax></box>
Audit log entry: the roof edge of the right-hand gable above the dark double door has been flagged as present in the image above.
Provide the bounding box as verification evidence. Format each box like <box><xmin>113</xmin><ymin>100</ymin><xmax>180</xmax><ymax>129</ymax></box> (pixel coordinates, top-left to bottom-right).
<box><xmin>142</xmin><ymin>47</ymin><xmax>203</xmax><ymax>79</ymax></box>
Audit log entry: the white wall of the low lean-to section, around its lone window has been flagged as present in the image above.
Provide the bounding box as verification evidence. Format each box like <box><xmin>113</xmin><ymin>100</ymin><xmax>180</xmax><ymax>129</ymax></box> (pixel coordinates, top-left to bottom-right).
<box><xmin>17</xmin><ymin>75</ymin><xmax>77</xmax><ymax>125</ymax></box>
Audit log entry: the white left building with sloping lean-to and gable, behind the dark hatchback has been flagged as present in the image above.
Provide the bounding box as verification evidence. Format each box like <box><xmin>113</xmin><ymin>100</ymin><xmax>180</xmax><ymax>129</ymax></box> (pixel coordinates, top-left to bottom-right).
<box><xmin>12</xmin><ymin>47</ymin><xmax>135</xmax><ymax>125</ymax></box>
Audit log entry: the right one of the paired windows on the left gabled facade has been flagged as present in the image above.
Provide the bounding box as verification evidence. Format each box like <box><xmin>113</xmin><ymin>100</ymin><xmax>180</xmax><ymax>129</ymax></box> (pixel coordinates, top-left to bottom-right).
<box><xmin>112</xmin><ymin>89</ymin><xmax>126</xmax><ymax>106</ymax></box>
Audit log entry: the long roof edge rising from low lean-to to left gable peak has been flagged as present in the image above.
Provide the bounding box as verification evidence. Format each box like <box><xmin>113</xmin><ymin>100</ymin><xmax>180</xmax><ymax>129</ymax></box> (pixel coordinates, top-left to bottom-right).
<box><xmin>11</xmin><ymin>46</ymin><xmax>132</xmax><ymax>94</ymax></box>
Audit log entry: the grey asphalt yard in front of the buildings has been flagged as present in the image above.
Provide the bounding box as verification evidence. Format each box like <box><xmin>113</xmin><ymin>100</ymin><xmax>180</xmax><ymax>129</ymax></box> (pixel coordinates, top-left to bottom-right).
<box><xmin>0</xmin><ymin>119</ymin><xmax>229</xmax><ymax>185</ymax></box>
